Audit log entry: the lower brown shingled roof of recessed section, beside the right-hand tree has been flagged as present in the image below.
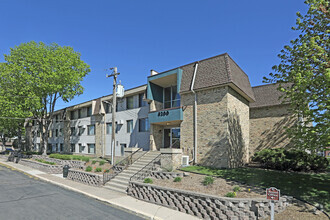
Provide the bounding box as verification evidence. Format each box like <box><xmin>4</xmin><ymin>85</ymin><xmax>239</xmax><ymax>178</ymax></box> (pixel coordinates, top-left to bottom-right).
<box><xmin>250</xmin><ymin>84</ymin><xmax>290</xmax><ymax>108</ymax></box>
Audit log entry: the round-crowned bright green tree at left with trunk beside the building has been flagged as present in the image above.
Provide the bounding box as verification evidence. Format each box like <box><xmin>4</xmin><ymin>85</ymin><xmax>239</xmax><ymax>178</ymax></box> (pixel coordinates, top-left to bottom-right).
<box><xmin>0</xmin><ymin>41</ymin><xmax>90</xmax><ymax>154</ymax></box>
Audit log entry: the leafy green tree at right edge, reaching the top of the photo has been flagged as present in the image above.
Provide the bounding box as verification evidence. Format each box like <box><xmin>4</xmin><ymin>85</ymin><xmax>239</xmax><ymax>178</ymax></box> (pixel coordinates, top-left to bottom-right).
<box><xmin>264</xmin><ymin>0</ymin><xmax>330</xmax><ymax>152</ymax></box>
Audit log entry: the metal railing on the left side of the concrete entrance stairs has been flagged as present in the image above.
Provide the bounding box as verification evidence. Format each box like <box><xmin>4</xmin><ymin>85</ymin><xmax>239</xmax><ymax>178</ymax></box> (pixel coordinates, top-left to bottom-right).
<box><xmin>103</xmin><ymin>148</ymin><xmax>147</xmax><ymax>185</ymax></box>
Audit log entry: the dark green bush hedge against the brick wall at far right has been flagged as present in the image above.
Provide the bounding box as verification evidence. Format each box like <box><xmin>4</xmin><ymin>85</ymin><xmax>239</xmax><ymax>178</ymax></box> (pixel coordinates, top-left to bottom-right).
<box><xmin>252</xmin><ymin>148</ymin><xmax>329</xmax><ymax>171</ymax></box>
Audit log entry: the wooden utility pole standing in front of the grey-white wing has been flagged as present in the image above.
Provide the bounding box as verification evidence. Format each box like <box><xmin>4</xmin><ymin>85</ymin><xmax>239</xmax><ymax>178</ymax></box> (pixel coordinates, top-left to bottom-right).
<box><xmin>106</xmin><ymin>67</ymin><xmax>120</xmax><ymax>165</ymax></box>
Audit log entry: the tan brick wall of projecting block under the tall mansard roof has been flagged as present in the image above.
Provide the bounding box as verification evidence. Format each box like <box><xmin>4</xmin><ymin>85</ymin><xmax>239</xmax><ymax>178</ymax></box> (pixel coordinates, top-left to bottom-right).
<box><xmin>181</xmin><ymin>86</ymin><xmax>249</xmax><ymax>168</ymax></box>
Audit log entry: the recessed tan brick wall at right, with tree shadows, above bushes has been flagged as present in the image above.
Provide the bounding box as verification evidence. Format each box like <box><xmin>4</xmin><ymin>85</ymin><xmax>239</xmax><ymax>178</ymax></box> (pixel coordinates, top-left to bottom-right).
<box><xmin>250</xmin><ymin>105</ymin><xmax>297</xmax><ymax>156</ymax></box>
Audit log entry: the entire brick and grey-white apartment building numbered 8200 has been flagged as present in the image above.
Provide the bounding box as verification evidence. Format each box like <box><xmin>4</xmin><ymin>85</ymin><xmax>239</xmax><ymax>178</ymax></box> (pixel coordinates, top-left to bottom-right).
<box><xmin>27</xmin><ymin>53</ymin><xmax>296</xmax><ymax>168</ymax></box>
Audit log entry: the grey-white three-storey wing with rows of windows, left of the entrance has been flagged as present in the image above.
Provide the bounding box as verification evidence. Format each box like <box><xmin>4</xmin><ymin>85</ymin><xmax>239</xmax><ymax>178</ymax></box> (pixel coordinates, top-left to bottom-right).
<box><xmin>27</xmin><ymin>85</ymin><xmax>149</xmax><ymax>156</ymax></box>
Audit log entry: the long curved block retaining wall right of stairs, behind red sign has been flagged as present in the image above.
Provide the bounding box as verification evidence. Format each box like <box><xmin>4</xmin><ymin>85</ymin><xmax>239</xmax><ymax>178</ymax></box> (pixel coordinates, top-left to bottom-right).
<box><xmin>127</xmin><ymin>182</ymin><xmax>290</xmax><ymax>220</ymax></box>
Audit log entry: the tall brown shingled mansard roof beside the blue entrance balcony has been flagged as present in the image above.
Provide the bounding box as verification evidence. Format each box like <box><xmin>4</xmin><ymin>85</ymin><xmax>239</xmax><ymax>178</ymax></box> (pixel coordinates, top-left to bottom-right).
<box><xmin>175</xmin><ymin>53</ymin><xmax>255</xmax><ymax>101</ymax></box>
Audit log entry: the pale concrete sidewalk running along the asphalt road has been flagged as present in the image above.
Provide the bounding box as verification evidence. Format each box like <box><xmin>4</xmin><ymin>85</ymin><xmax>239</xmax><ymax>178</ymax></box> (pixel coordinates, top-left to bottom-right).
<box><xmin>0</xmin><ymin>158</ymin><xmax>198</xmax><ymax>220</ymax></box>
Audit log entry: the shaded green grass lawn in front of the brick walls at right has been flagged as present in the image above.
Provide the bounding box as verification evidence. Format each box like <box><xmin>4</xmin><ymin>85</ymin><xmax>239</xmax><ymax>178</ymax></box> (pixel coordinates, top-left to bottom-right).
<box><xmin>181</xmin><ymin>166</ymin><xmax>330</xmax><ymax>212</ymax></box>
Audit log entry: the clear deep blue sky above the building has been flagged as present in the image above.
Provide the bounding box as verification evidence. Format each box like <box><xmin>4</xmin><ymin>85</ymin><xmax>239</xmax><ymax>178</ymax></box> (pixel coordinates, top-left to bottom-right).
<box><xmin>0</xmin><ymin>0</ymin><xmax>307</xmax><ymax>109</ymax></box>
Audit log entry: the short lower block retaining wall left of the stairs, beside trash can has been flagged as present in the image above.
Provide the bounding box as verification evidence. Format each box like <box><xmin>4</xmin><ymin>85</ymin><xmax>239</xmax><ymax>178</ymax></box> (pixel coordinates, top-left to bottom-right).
<box><xmin>67</xmin><ymin>169</ymin><xmax>103</xmax><ymax>186</ymax></box>
